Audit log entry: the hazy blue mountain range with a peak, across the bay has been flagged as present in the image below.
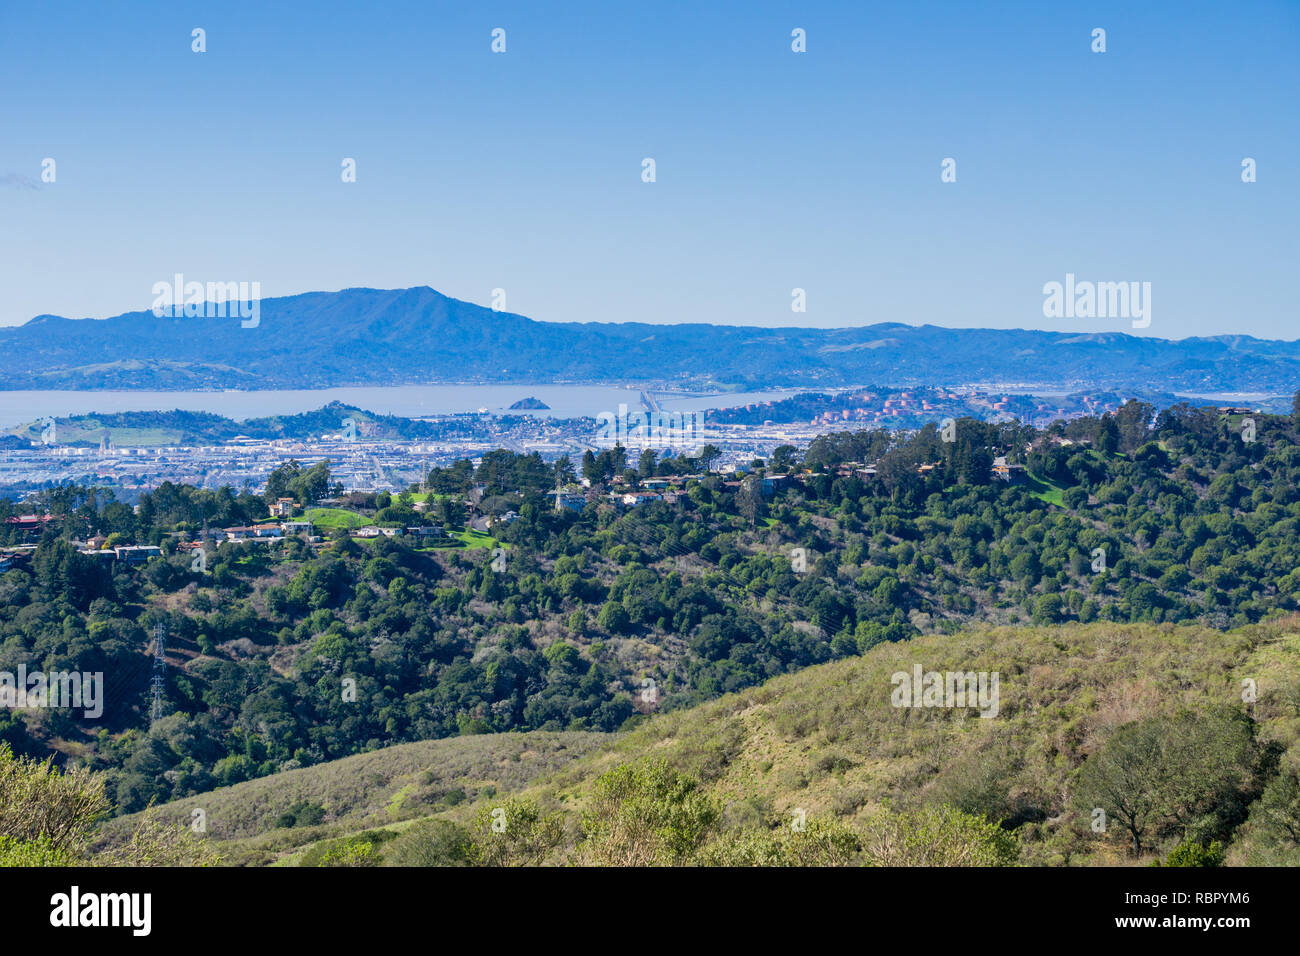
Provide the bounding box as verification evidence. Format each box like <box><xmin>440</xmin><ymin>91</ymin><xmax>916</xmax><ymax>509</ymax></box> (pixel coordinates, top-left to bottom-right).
<box><xmin>0</xmin><ymin>287</ymin><xmax>1300</xmax><ymax>394</ymax></box>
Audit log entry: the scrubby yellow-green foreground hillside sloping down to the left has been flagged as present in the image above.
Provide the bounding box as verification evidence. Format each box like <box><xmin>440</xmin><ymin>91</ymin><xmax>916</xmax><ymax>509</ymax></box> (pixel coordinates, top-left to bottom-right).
<box><xmin>96</xmin><ymin>618</ymin><xmax>1300</xmax><ymax>865</ymax></box>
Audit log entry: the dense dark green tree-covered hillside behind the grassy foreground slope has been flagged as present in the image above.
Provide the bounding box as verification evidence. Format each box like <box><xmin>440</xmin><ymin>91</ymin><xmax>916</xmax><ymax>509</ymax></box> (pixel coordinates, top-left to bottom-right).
<box><xmin>0</xmin><ymin>402</ymin><xmax>1300</xmax><ymax>813</ymax></box>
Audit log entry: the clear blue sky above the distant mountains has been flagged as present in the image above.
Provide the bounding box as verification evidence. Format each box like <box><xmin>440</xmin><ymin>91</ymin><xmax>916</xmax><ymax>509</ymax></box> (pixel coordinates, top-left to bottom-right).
<box><xmin>0</xmin><ymin>0</ymin><xmax>1300</xmax><ymax>339</ymax></box>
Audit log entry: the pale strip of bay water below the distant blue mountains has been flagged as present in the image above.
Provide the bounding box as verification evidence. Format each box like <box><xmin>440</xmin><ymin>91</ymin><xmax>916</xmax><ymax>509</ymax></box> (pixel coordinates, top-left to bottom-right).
<box><xmin>0</xmin><ymin>385</ymin><xmax>792</xmax><ymax>428</ymax></box>
